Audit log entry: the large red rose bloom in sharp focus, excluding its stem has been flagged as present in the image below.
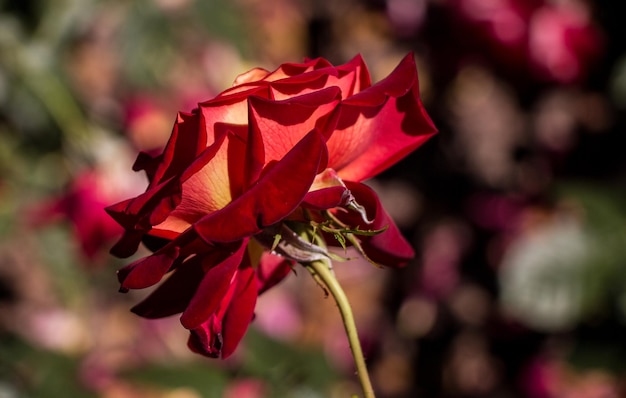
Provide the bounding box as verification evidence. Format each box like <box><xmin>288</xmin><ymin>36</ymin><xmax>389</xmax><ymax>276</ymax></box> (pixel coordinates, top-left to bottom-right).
<box><xmin>107</xmin><ymin>55</ymin><xmax>436</xmax><ymax>358</ymax></box>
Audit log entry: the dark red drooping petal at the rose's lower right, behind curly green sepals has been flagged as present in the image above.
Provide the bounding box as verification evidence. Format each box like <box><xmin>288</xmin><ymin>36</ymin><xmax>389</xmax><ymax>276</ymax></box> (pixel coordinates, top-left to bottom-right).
<box><xmin>336</xmin><ymin>181</ymin><xmax>415</xmax><ymax>267</ymax></box>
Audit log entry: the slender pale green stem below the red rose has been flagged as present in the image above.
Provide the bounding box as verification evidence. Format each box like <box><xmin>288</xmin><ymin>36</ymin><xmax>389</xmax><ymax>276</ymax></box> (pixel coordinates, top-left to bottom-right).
<box><xmin>305</xmin><ymin>260</ymin><xmax>375</xmax><ymax>398</ymax></box>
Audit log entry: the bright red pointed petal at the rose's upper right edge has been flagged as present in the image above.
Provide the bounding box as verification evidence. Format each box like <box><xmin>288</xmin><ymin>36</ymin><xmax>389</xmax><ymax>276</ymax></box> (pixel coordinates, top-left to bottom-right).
<box><xmin>328</xmin><ymin>54</ymin><xmax>437</xmax><ymax>181</ymax></box>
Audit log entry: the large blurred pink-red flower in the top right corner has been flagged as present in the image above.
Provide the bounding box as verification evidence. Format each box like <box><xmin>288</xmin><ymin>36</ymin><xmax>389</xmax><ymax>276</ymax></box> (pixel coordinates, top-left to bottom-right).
<box><xmin>450</xmin><ymin>0</ymin><xmax>603</xmax><ymax>83</ymax></box>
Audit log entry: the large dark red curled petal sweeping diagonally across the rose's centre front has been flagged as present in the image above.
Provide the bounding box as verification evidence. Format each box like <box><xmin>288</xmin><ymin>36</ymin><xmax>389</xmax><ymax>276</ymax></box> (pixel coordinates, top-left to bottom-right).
<box><xmin>194</xmin><ymin>130</ymin><xmax>326</xmax><ymax>243</ymax></box>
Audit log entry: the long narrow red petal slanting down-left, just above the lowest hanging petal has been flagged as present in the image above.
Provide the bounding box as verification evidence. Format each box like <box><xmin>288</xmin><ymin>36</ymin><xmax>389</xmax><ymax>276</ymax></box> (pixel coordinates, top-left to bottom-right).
<box><xmin>180</xmin><ymin>240</ymin><xmax>247</xmax><ymax>329</ymax></box>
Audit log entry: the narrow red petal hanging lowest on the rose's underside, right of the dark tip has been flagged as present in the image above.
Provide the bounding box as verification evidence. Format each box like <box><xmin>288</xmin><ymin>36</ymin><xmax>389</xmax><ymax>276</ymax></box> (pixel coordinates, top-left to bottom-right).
<box><xmin>222</xmin><ymin>267</ymin><xmax>257</xmax><ymax>359</ymax></box>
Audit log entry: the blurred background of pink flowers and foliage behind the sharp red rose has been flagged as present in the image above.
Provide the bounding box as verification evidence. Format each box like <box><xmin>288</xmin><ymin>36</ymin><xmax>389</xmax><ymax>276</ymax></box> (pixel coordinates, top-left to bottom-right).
<box><xmin>0</xmin><ymin>0</ymin><xmax>626</xmax><ymax>398</ymax></box>
